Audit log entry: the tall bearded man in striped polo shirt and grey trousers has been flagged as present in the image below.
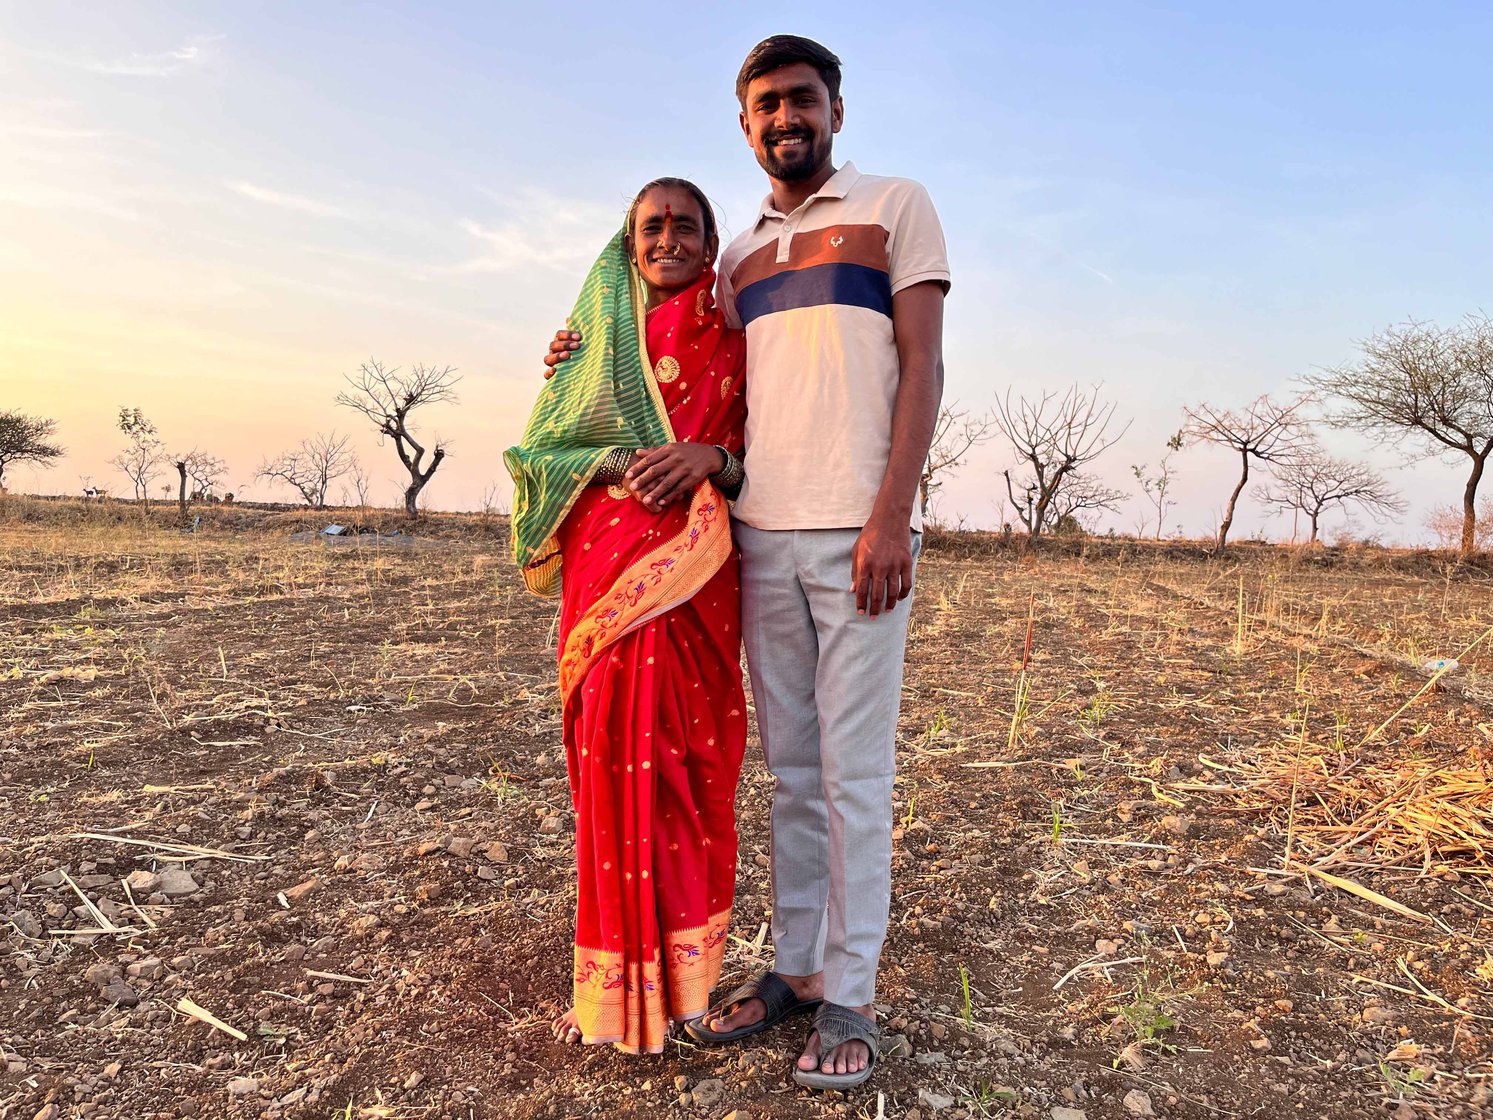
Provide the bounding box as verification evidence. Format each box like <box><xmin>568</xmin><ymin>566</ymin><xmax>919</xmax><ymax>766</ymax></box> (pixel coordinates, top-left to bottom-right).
<box><xmin>546</xmin><ymin>36</ymin><xmax>950</xmax><ymax>1089</ymax></box>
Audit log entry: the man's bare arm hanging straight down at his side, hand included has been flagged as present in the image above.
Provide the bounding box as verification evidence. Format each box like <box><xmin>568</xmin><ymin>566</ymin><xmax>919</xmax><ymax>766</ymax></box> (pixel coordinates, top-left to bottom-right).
<box><xmin>851</xmin><ymin>281</ymin><xmax>944</xmax><ymax>615</ymax></box>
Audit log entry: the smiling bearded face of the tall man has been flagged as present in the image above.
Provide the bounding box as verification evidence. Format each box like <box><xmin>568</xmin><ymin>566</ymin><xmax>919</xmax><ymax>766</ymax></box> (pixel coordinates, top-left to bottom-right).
<box><xmin>741</xmin><ymin>63</ymin><xmax>845</xmax><ymax>182</ymax></box>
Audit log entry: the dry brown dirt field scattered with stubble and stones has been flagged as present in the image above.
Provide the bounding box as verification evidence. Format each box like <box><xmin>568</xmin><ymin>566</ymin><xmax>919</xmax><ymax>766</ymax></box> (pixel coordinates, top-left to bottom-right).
<box><xmin>0</xmin><ymin>501</ymin><xmax>1493</xmax><ymax>1120</ymax></box>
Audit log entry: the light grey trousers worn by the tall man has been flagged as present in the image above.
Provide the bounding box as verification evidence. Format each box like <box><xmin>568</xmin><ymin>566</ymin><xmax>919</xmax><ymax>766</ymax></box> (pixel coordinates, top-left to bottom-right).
<box><xmin>733</xmin><ymin>523</ymin><xmax>921</xmax><ymax>1007</ymax></box>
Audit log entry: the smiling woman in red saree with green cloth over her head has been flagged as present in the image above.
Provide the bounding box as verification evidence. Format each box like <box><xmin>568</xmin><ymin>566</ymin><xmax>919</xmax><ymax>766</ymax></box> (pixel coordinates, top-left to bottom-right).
<box><xmin>505</xmin><ymin>179</ymin><xmax>747</xmax><ymax>1053</ymax></box>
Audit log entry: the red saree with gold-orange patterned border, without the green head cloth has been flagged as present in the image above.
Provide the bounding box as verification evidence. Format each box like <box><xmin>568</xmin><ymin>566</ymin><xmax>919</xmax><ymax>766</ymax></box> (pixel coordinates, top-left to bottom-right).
<box><xmin>558</xmin><ymin>272</ymin><xmax>747</xmax><ymax>1053</ymax></box>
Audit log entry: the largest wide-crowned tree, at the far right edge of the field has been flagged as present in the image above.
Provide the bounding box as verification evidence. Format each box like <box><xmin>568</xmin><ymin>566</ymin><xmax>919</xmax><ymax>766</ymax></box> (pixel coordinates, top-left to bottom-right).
<box><xmin>1306</xmin><ymin>315</ymin><xmax>1493</xmax><ymax>556</ymax></box>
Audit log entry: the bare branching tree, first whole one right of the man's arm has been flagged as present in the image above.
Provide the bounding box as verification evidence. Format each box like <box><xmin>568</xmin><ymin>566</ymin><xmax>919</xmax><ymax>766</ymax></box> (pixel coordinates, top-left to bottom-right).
<box><xmin>993</xmin><ymin>385</ymin><xmax>1130</xmax><ymax>539</ymax></box>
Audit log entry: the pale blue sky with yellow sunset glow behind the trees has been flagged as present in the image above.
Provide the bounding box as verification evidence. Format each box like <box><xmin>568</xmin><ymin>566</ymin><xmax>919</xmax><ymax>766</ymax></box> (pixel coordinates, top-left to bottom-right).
<box><xmin>0</xmin><ymin>0</ymin><xmax>1493</xmax><ymax>542</ymax></box>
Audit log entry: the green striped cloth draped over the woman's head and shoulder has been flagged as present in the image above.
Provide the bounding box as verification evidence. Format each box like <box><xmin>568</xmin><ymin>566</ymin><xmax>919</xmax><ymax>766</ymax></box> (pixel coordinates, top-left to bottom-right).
<box><xmin>503</xmin><ymin>230</ymin><xmax>673</xmax><ymax>596</ymax></box>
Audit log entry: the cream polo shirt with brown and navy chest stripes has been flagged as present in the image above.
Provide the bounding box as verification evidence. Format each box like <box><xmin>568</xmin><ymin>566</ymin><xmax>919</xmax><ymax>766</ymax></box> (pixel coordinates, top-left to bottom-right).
<box><xmin>718</xmin><ymin>163</ymin><xmax>950</xmax><ymax>529</ymax></box>
